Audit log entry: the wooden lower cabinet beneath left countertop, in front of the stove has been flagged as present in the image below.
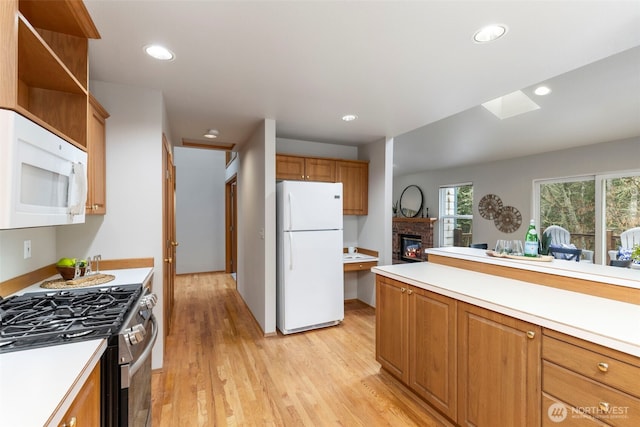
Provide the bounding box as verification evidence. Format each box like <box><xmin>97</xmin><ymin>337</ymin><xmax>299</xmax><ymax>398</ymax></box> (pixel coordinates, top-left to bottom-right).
<box><xmin>58</xmin><ymin>362</ymin><xmax>100</xmax><ymax>427</ymax></box>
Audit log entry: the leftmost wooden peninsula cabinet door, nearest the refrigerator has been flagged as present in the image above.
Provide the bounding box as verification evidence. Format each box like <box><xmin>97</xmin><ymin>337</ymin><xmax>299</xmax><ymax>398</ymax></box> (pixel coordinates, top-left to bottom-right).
<box><xmin>376</xmin><ymin>276</ymin><xmax>409</xmax><ymax>383</ymax></box>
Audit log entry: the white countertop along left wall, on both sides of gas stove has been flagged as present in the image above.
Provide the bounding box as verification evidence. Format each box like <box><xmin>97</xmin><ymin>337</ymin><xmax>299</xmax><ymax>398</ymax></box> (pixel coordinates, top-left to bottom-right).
<box><xmin>0</xmin><ymin>267</ymin><xmax>153</xmax><ymax>426</ymax></box>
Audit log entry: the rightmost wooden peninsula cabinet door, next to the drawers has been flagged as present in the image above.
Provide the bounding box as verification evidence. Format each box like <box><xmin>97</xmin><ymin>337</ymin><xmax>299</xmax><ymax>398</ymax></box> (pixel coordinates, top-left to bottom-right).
<box><xmin>458</xmin><ymin>303</ymin><xmax>541</xmax><ymax>427</ymax></box>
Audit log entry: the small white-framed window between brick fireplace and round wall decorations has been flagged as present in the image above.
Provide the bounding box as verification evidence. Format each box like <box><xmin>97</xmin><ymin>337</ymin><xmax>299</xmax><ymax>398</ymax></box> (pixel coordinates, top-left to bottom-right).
<box><xmin>438</xmin><ymin>183</ymin><xmax>473</xmax><ymax>247</ymax></box>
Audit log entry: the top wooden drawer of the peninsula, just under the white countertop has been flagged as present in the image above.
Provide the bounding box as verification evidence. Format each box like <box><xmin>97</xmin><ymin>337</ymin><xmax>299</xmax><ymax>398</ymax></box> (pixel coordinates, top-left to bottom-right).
<box><xmin>542</xmin><ymin>336</ymin><xmax>640</xmax><ymax>398</ymax></box>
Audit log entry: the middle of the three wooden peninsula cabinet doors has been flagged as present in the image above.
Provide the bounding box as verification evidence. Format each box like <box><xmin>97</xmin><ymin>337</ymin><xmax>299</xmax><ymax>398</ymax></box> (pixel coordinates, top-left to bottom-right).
<box><xmin>408</xmin><ymin>287</ymin><xmax>457</xmax><ymax>419</ymax></box>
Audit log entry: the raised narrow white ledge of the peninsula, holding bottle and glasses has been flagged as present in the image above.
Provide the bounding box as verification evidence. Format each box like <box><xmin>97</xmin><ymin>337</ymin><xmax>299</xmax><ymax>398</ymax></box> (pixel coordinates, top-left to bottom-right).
<box><xmin>425</xmin><ymin>247</ymin><xmax>640</xmax><ymax>289</ymax></box>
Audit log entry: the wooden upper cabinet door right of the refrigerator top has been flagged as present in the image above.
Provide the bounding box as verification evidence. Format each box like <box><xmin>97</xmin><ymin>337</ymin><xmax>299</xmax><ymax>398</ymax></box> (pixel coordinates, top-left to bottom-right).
<box><xmin>336</xmin><ymin>160</ymin><xmax>369</xmax><ymax>215</ymax></box>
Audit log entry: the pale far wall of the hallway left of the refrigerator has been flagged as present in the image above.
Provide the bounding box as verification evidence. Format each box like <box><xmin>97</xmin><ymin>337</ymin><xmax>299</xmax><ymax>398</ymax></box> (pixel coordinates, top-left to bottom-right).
<box><xmin>173</xmin><ymin>147</ymin><xmax>226</xmax><ymax>274</ymax></box>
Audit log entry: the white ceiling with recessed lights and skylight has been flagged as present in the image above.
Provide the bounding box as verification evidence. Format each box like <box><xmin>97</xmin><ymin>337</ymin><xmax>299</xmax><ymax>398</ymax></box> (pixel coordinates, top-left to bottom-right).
<box><xmin>85</xmin><ymin>0</ymin><xmax>640</xmax><ymax>173</ymax></box>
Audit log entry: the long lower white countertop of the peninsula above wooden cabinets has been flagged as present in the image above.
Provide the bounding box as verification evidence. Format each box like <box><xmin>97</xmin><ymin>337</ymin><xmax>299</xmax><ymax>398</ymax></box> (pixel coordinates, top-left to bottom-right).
<box><xmin>371</xmin><ymin>262</ymin><xmax>640</xmax><ymax>357</ymax></box>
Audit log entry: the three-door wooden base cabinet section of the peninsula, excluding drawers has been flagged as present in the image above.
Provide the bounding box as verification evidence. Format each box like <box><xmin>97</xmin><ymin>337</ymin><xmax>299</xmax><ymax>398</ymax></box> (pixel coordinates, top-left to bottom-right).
<box><xmin>376</xmin><ymin>276</ymin><xmax>542</xmax><ymax>427</ymax></box>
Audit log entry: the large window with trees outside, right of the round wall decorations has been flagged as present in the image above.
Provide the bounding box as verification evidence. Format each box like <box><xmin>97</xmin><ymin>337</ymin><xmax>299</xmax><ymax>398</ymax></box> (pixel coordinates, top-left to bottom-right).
<box><xmin>534</xmin><ymin>171</ymin><xmax>640</xmax><ymax>264</ymax></box>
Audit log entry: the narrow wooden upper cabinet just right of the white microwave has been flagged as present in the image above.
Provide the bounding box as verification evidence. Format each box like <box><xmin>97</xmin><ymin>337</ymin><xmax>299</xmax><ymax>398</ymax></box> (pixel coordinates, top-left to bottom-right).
<box><xmin>86</xmin><ymin>95</ymin><xmax>109</xmax><ymax>215</ymax></box>
